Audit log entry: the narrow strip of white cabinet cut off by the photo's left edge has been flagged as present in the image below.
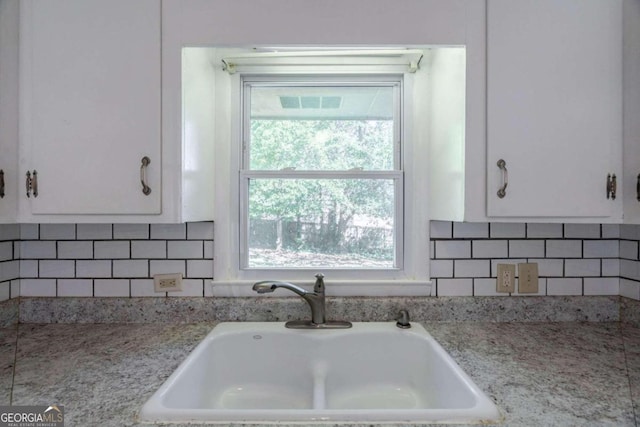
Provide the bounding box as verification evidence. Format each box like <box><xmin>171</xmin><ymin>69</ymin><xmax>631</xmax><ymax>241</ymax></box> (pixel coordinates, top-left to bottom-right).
<box><xmin>0</xmin><ymin>0</ymin><xmax>19</xmax><ymax>224</ymax></box>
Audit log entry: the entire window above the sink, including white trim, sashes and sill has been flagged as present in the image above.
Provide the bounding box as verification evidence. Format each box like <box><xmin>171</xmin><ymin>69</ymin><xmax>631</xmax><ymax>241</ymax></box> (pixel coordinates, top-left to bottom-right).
<box><xmin>210</xmin><ymin>51</ymin><xmax>431</xmax><ymax>296</ymax></box>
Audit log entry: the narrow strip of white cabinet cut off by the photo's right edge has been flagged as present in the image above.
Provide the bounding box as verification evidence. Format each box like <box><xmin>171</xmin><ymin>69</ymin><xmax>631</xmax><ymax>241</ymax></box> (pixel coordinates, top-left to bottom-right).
<box><xmin>623</xmin><ymin>0</ymin><xmax>640</xmax><ymax>224</ymax></box>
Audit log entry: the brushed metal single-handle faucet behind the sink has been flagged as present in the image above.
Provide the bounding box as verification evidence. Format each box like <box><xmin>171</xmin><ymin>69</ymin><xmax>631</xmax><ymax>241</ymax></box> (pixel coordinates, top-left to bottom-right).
<box><xmin>253</xmin><ymin>273</ymin><xmax>351</xmax><ymax>329</ymax></box>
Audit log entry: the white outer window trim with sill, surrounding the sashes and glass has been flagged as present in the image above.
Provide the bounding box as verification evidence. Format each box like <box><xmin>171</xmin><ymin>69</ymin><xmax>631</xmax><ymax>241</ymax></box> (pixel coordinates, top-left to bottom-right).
<box><xmin>211</xmin><ymin>68</ymin><xmax>432</xmax><ymax>296</ymax></box>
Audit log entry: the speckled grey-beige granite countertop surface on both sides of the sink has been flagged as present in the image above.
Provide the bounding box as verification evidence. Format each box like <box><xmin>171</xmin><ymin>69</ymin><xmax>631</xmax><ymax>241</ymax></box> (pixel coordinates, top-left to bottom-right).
<box><xmin>0</xmin><ymin>322</ymin><xmax>640</xmax><ymax>427</ymax></box>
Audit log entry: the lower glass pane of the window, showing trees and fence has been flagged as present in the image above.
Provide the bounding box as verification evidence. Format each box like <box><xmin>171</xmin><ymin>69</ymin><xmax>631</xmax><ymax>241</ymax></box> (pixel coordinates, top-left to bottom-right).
<box><xmin>248</xmin><ymin>178</ymin><xmax>395</xmax><ymax>269</ymax></box>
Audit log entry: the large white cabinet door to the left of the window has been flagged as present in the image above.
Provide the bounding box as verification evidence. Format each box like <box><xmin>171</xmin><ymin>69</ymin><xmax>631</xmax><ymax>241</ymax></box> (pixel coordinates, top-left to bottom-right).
<box><xmin>20</xmin><ymin>0</ymin><xmax>161</xmax><ymax>214</ymax></box>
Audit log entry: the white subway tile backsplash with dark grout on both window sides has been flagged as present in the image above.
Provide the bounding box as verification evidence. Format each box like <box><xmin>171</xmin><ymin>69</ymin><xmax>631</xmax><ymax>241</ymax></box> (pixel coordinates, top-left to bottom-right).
<box><xmin>6</xmin><ymin>221</ymin><xmax>640</xmax><ymax>300</ymax></box>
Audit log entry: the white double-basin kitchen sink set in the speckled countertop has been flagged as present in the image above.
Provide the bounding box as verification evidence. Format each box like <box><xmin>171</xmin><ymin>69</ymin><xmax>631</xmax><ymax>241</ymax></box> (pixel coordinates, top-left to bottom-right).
<box><xmin>140</xmin><ymin>322</ymin><xmax>500</xmax><ymax>423</ymax></box>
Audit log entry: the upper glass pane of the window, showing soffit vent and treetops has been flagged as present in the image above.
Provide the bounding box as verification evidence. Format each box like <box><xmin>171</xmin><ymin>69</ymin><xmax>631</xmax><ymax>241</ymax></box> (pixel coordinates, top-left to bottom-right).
<box><xmin>249</xmin><ymin>86</ymin><xmax>395</xmax><ymax>170</ymax></box>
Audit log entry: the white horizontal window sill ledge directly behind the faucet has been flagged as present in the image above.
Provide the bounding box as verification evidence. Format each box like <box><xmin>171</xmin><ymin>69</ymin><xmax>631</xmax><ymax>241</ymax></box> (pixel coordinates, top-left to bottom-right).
<box><xmin>209</xmin><ymin>280</ymin><xmax>432</xmax><ymax>297</ymax></box>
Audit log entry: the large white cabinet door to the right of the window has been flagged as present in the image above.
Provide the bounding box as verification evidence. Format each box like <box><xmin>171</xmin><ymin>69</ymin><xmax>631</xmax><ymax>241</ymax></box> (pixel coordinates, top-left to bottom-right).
<box><xmin>487</xmin><ymin>0</ymin><xmax>622</xmax><ymax>217</ymax></box>
